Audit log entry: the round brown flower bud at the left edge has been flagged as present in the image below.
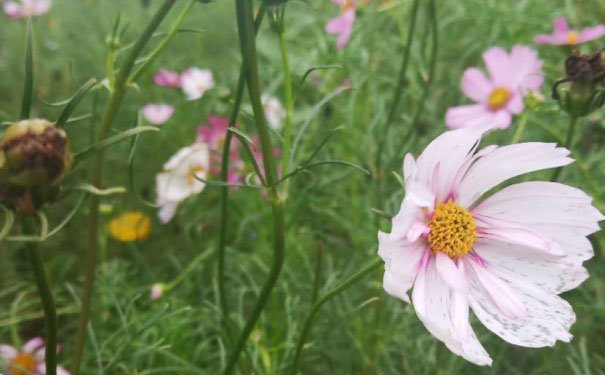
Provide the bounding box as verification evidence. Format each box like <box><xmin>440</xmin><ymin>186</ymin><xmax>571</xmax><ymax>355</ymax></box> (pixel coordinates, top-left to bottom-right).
<box><xmin>0</xmin><ymin>119</ymin><xmax>73</xmax><ymax>190</ymax></box>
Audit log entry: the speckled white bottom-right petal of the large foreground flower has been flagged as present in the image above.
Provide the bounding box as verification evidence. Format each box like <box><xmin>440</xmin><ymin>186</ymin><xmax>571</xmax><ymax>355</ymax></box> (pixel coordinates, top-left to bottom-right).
<box><xmin>469</xmin><ymin>260</ymin><xmax>575</xmax><ymax>348</ymax></box>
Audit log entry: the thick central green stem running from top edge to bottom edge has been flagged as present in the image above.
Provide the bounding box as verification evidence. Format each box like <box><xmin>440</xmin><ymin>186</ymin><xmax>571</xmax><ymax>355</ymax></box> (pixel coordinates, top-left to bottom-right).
<box><xmin>224</xmin><ymin>0</ymin><xmax>285</xmax><ymax>375</ymax></box>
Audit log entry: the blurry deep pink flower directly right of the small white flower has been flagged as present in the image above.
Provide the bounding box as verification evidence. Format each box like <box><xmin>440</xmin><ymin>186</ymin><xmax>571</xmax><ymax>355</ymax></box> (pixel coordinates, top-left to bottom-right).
<box><xmin>197</xmin><ymin>116</ymin><xmax>244</xmax><ymax>184</ymax></box>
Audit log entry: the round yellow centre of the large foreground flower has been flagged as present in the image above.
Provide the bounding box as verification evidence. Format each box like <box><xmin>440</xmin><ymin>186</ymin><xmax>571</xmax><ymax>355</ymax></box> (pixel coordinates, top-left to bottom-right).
<box><xmin>427</xmin><ymin>201</ymin><xmax>477</xmax><ymax>259</ymax></box>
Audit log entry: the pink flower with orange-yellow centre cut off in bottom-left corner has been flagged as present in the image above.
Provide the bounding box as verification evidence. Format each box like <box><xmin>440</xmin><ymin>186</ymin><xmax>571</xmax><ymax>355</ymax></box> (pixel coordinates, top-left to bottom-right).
<box><xmin>0</xmin><ymin>337</ymin><xmax>69</xmax><ymax>375</ymax></box>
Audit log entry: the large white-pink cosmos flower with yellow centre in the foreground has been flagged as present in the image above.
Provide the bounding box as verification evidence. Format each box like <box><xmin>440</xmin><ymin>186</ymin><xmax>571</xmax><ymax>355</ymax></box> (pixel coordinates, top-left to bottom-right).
<box><xmin>378</xmin><ymin>126</ymin><xmax>604</xmax><ymax>365</ymax></box>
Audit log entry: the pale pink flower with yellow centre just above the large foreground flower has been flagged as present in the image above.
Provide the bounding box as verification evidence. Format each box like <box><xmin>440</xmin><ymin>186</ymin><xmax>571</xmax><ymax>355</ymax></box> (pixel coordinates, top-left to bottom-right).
<box><xmin>445</xmin><ymin>45</ymin><xmax>544</xmax><ymax>129</ymax></box>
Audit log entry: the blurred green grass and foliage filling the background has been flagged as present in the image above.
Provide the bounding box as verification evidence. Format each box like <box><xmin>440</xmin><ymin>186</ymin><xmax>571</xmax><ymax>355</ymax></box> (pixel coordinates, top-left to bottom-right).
<box><xmin>0</xmin><ymin>0</ymin><xmax>605</xmax><ymax>374</ymax></box>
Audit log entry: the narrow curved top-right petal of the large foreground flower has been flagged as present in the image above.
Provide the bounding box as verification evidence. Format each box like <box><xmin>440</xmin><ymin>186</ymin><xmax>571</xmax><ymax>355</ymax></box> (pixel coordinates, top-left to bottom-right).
<box><xmin>458</xmin><ymin>142</ymin><xmax>573</xmax><ymax>207</ymax></box>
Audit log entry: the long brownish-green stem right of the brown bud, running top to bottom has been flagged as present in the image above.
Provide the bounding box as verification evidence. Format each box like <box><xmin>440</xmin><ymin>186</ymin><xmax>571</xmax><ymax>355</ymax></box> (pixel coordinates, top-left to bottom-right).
<box><xmin>71</xmin><ymin>0</ymin><xmax>176</xmax><ymax>375</ymax></box>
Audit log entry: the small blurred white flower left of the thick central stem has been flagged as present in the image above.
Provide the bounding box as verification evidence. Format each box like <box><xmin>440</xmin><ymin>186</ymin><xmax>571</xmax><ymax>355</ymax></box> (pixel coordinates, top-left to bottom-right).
<box><xmin>156</xmin><ymin>143</ymin><xmax>210</xmax><ymax>223</ymax></box>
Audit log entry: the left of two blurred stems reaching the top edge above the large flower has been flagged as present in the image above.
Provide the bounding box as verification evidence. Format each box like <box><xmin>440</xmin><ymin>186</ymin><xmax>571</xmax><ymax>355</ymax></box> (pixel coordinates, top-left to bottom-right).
<box><xmin>376</xmin><ymin>0</ymin><xmax>420</xmax><ymax>209</ymax></box>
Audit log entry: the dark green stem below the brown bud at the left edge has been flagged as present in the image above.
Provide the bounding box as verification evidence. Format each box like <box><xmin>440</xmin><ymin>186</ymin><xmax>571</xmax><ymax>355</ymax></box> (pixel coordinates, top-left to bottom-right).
<box><xmin>21</xmin><ymin>218</ymin><xmax>57</xmax><ymax>375</ymax></box>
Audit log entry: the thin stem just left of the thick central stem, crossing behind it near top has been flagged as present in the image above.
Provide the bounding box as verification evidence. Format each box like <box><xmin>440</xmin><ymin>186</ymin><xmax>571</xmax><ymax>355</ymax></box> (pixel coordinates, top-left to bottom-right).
<box><xmin>218</xmin><ymin>6</ymin><xmax>265</xmax><ymax>317</ymax></box>
